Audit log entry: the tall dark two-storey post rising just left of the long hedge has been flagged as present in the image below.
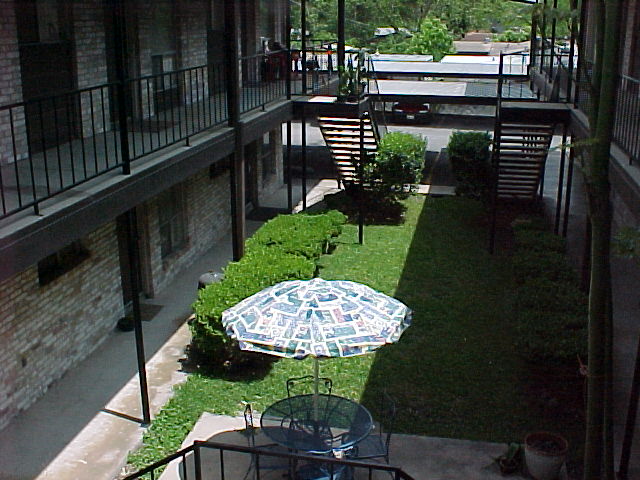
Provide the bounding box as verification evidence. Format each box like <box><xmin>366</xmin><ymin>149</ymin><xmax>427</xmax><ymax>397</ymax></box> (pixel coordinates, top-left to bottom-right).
<box><xmin>224</xmin><ymin>0</ymin><xmax>246</xmax><ymax>261</ymax></box>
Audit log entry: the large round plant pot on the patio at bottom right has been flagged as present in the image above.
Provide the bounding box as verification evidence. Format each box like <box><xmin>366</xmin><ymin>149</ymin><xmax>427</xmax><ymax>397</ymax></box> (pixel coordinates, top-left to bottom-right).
<box><xmin>524</xmin><ymin>432</ymin><xmax>569</xmax><ymax>480</ymax></box>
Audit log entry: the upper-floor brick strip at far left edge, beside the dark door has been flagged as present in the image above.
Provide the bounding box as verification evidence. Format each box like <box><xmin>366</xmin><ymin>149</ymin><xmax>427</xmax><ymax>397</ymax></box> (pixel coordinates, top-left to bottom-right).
<box><xmin>0</xmin><ymin>0</ymin><xmax>27</xmax><ymax>165</ymax></box>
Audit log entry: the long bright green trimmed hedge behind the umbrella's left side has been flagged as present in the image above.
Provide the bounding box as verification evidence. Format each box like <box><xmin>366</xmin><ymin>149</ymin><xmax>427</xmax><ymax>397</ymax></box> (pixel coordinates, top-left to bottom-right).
<box><xmin>190</xmin><ymin>211</ymin><xmax>346</xmax><ymax>370</ymax></box>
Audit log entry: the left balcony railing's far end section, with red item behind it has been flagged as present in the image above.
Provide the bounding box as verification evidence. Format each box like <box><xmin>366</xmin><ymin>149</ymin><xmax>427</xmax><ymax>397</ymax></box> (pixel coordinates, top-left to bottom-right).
<box><xmin>240</xmin><ymin>50</ymin><xmax>290</xmax><ymax>113</ymax></box>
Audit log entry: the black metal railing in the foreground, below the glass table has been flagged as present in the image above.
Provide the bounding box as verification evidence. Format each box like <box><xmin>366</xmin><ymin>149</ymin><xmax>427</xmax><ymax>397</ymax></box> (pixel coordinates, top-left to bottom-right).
<box><xmin>123</xmin><ymin>441</ymin><xmax>413</xmax><ymax>480</ymax></box>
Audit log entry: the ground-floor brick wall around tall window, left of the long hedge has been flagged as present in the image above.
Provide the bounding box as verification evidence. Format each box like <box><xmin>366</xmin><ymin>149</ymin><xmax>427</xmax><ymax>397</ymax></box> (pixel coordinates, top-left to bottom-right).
<box><xmin>144</xmin><ymin>168</ymin><xmax>231</xmax><ymax>291</ymax></box>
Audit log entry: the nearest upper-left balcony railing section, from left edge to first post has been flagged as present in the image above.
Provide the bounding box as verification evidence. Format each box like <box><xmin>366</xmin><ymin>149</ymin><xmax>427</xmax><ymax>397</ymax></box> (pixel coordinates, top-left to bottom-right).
<box><xmin>0</xmin><ymin>84</ymin><xmax>125</xmax><ymax>217</ymax></box>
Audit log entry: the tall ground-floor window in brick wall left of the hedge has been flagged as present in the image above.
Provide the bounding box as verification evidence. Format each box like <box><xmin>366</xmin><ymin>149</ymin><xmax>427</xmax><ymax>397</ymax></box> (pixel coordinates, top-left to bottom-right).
<box><xmin>158</xmin><ymin>185</ymin><xmax>187</xmax><ymax>259</ymax></box>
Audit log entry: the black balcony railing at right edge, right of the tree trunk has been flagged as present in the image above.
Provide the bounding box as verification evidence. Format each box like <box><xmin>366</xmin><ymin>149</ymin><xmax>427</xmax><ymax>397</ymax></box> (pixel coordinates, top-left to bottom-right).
<box><xmin>613</xmin><ymin>75</ymin><xmax>640</xmax><ymax>163</ymax></box>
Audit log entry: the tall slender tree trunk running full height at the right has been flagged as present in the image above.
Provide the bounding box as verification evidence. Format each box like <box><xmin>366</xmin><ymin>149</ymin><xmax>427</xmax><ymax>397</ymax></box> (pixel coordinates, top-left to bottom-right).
<box><xmin>584</xmin><ymin>0</ymin><xmax>619</xmax><ymax>480</ymax></box>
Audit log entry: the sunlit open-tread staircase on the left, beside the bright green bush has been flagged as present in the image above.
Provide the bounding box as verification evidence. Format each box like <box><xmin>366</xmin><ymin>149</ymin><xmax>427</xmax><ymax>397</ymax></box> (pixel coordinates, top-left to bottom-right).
<box><xmin>318</xmin><ymin>114</ymin><xmax>379</xmax><ymax>185</ymax></box>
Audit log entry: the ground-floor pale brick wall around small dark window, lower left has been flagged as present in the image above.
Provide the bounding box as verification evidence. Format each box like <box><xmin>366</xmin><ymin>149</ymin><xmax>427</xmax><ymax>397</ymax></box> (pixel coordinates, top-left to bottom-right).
<box><xmin>0</xmin><ymin>222</ymin><xmax>123</xmax><ymax>428</ymax></box>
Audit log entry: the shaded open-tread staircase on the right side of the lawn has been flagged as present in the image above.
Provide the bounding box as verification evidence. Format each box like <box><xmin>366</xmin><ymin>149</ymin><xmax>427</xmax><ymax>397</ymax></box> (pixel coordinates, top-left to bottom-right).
<box><xmin>493</xmin><ymin>122</ymin><xmax>554</xmax><ymax>200</ymax></box>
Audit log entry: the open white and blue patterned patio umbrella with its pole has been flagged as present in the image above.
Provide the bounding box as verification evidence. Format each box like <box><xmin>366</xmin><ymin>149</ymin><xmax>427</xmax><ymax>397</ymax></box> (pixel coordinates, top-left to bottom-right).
<box><xmin>222</xmin><ymin>278</ymin><xmax>411</xmax><ymax>412</ymax></box>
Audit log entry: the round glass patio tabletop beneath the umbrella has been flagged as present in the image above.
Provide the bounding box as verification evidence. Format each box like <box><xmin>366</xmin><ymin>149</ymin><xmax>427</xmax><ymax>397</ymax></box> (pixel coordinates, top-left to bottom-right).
<box><xmin>260</xmin><ymin>394</ymin><xmax>373</xmax><ymax>455</ymax></box>
